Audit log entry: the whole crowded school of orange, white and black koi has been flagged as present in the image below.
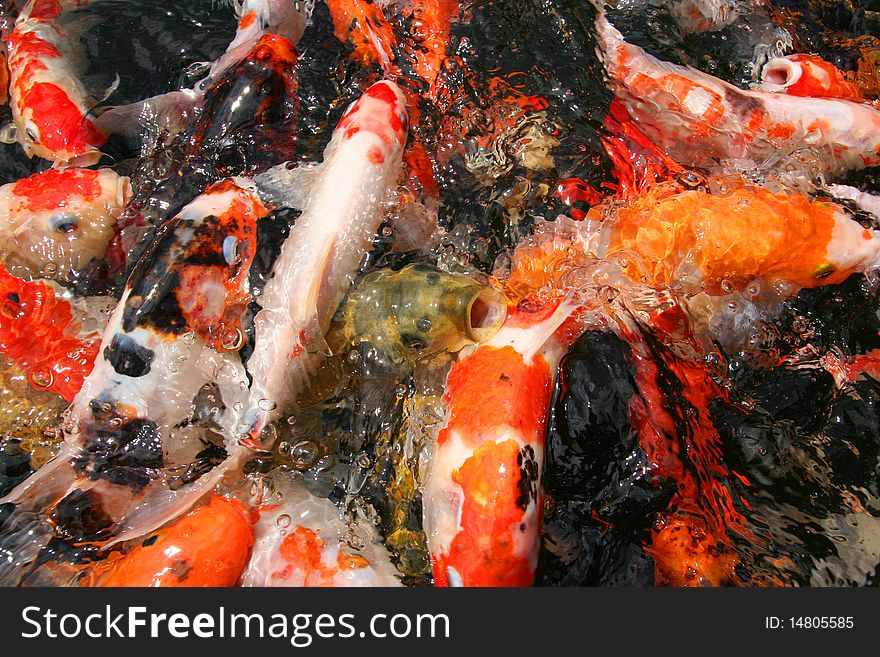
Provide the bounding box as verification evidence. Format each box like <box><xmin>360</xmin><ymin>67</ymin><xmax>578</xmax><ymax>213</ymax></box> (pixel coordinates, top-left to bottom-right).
<box><xmin>0</xmin><ymin>0</ymin><xmax>880</xmax><ymax>587</ymax></box>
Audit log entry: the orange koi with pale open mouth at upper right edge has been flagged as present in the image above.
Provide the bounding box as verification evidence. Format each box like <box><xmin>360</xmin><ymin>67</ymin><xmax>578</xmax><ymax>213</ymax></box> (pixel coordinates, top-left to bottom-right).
<box><xmin>758</xmin><ymin>54</ymin><xmax>865</xmax><ymax>102</ymax></box>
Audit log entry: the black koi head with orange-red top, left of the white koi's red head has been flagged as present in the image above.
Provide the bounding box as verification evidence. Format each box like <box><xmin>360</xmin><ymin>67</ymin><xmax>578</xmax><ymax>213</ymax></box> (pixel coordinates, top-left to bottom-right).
<box><xmin>189</xmin><ymin>34</ymin><xmax>298</xmax><ymax>165</ymax></box>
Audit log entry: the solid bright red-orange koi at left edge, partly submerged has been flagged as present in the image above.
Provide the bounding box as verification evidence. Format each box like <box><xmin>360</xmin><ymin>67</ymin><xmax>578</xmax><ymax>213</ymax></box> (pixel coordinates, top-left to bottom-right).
<box><xmin>0</xmin><ymin>263</ymin><xmax>100</xmax><ymax>402</ymax></box>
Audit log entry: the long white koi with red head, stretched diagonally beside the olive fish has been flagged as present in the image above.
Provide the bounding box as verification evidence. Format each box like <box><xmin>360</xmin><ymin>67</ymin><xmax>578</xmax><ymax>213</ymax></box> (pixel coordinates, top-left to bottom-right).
<box><xmin>239</xmin><ymin>81</ymin><xmax>407</xmax><ymax>444</ymax></box>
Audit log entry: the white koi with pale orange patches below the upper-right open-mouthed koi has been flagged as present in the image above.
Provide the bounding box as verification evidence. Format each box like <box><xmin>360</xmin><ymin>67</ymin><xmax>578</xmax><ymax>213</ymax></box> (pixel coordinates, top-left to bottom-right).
<box><xmin>596</xmin><ymin>11</ymin><xmax>880</xmax><ymax>176</ymax></box>
